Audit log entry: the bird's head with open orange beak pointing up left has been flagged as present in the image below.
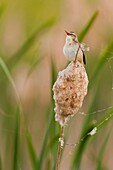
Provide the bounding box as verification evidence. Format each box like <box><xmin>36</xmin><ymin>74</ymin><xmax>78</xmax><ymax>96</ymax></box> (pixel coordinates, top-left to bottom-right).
<box><xmin>65</xmin><ymin>31</ymin><xmax>78</xmax><ymax>43</ymax></box>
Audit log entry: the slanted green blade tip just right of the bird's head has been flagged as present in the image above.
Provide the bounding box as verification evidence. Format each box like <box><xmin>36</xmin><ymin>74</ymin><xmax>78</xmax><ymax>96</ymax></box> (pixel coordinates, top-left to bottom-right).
<box><xmin>78</xmin><ymin>11</ymin><xmax>99</xmax><ymax>42</ymax></box>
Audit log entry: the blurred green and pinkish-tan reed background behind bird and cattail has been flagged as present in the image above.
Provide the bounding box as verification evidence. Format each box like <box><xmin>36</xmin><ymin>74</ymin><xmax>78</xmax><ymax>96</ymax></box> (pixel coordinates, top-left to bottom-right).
<box><xmin>0</xmin><ymin>0</ymin><xmax>113</xmax><ymax>170</ymax></box>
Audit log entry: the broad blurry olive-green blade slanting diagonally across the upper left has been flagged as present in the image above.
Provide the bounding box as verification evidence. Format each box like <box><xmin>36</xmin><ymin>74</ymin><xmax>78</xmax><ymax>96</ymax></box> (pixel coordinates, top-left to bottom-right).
<box><xmin>8</xmin><ymin>18</ymin><xmax>55</xmax><ymax>69</ymax></box>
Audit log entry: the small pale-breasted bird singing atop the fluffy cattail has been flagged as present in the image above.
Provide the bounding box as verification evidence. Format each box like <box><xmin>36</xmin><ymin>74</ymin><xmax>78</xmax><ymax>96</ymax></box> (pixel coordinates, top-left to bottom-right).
<box><xmin>63</xmin><ymin>31</ymin><xmax>86</xmax><ymax>64</ymax></box>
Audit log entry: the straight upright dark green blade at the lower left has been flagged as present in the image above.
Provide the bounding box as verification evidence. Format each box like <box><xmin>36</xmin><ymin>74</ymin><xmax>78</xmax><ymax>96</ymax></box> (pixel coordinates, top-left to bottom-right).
<box><xmin>13</xmin><ymin>108</ymin><xmax>20</xmax><ymax>170</ymax></box>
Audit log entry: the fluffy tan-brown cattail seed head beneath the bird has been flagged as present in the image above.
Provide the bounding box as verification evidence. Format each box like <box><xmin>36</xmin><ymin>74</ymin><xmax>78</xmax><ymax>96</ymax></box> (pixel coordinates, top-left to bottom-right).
<box><xmin>53</xmin><ymin>61</ymin><xmax>88</xmax><ymax>126</ymax></box>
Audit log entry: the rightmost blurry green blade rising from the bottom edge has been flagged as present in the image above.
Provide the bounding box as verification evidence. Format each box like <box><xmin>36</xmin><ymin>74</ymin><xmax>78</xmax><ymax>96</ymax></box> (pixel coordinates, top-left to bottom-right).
<box><xmin>96</xmin><ymin>133</ymin><xmax>110</xmax><ymax>170</ymax></box>
